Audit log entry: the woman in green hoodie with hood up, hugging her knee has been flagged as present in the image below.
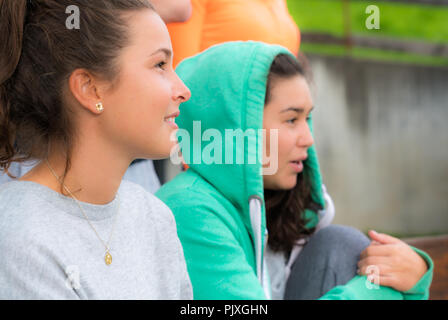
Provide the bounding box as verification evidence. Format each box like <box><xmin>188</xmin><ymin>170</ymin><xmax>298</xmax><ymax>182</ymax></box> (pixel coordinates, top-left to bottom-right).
<box><xmin>157</xmin><ymin>42</ymin><xmax>432</xmax><ymax>299</ymax></box>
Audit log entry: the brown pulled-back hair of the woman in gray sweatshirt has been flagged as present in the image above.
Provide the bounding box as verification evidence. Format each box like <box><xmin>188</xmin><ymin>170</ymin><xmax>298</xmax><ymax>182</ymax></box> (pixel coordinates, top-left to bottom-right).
<box><xmin>0</xmin><ymin>0</ymin><xmax>153</xmax><ymax>185</ymax></box>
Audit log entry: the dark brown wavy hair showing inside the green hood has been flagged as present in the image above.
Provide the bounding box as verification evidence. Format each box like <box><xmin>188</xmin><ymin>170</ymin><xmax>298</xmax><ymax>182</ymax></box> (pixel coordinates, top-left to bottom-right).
<box><xmin>264</xmin><ymin>54</ymin><xmax>318</xmax><ymax>253</ymax></box>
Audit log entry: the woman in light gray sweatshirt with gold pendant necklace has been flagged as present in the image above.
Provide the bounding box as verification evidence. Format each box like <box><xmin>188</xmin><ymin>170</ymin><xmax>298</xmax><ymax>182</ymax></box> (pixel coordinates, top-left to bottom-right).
<box><xmin>0</xmin><ymin>0</ymin><xmax>192</xmax><ymax>299</ymax></box>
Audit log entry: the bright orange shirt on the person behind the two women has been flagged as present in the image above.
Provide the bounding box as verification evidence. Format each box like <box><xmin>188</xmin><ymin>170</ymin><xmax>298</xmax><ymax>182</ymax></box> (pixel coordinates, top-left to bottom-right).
<box><xmin>168</xmin><ymin>0</ymin><xmax>300</xmax><ymax>66</ymax></box>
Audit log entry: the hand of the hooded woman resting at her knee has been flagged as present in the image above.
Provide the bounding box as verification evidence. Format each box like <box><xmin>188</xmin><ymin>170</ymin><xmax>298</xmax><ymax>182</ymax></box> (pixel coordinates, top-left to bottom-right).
<box><xmin>358</xmin><ymin>231</ymin><xmax>428</xmax><ymax>291</ymax></box>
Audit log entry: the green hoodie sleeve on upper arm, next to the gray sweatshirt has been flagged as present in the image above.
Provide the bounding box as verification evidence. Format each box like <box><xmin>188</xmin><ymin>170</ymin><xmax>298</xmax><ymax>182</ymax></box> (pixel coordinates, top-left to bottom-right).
<box><xmin>161</xmin><ymin>194</ymin><xmax>266</xmax><ymax>300</ymax></box>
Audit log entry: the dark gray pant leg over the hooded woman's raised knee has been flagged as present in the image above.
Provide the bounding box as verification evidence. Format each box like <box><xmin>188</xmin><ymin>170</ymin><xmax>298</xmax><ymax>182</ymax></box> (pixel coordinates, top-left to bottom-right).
<box><xmin>284</xmin><ymin>225</ymin><xmax>370</xmax><ymax>300</ymax></box>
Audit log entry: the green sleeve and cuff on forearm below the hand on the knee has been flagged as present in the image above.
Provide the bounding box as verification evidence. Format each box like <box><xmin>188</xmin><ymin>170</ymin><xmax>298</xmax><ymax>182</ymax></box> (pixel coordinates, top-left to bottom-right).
<box><xmin>320</xmin><ymin>247</ymin><xmax>434</xmax><ymax>300</ymax></box>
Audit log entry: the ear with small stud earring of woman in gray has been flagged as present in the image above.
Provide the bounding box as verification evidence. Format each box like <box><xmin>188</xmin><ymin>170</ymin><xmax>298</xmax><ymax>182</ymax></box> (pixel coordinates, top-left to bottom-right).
<box><xmin>68</xmin><ymin>69</ymin><xmax>104</xmax><ymax>114</ymax></box>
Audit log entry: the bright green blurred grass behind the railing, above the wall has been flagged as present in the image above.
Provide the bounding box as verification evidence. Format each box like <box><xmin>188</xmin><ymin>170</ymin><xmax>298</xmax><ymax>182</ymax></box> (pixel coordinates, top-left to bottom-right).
<box><xmin>287</xmin><ymin>0</ymin><xmax>448</xmax><ymax>65</ymax></box>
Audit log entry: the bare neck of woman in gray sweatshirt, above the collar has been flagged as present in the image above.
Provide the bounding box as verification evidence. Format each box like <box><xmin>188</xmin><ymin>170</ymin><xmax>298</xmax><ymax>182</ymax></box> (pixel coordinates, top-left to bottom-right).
<box><xmin>20</xmin><ymin>141</ymin><xmax>132</xmax><ymax>205</ymax></box>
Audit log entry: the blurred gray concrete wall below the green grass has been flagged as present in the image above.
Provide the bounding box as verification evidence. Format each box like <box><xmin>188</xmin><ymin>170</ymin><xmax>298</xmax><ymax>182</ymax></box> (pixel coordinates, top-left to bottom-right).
<box><xmin>310</xmin><ymin>57</ymin><xmax>448</xmax><ymax>235</ymax></box>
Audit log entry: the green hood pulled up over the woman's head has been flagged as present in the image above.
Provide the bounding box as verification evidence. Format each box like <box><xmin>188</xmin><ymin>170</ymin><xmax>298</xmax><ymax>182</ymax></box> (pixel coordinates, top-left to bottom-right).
<box><xmin>176</xmin><ymin>41</ymin><xmax>324</xmax><ymax>235</ymax></box>
